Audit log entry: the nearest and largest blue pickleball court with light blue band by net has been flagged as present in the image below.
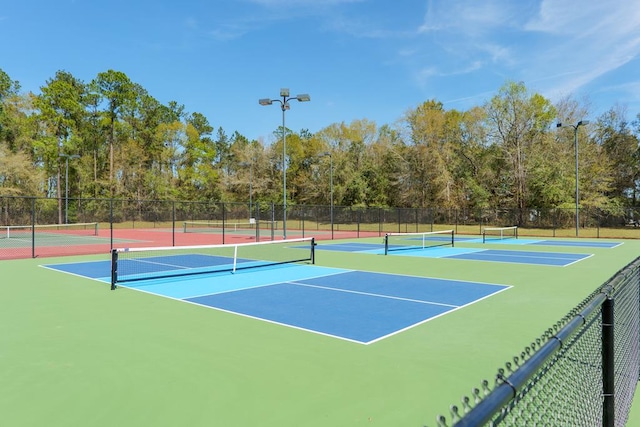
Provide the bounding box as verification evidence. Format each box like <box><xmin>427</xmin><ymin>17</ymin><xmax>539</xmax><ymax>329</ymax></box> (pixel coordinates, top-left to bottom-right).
<box><xmin>44</xmin><ymin>261</ymin><xmax>509</xmax><ymax>344</ymax></box>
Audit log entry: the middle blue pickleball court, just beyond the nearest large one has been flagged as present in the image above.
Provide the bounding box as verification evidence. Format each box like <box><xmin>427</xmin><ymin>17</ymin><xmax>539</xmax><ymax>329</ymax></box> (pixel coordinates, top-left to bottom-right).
<box><xmin>316</xmin><ymin>243</ymin><xmax>593</xmax><ymax>267</ymax></box>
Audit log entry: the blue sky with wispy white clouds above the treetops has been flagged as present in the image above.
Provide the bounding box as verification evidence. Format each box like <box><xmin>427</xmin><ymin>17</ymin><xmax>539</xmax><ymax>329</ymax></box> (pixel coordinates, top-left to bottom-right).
<box><xmin>0</xmin><ymin>0</ymin><xmax>640</xmax><ymax>143</ymax></box>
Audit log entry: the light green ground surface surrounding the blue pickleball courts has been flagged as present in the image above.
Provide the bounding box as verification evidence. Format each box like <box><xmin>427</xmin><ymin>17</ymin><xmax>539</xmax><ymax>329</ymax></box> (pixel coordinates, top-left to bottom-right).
<box><xmin>0</xmin><ymin>238</ymin><xmax>640</xmax><ymax>427</ymax></box>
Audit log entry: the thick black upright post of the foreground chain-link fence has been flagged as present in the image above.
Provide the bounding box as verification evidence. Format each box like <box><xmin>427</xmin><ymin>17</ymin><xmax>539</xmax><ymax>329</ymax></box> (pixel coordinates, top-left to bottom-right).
<box><xmin>602</xmin><ymin>297</ymin><xmax>616</xmax><ymax>427</ymax></box>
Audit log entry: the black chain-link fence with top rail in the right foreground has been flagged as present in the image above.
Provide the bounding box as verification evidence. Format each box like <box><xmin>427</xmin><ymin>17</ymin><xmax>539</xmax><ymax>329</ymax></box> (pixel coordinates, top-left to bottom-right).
<box><xmin>436</xmin><ymin>258</ymin><xmax>640</xmax><ymax>427</ymax></box>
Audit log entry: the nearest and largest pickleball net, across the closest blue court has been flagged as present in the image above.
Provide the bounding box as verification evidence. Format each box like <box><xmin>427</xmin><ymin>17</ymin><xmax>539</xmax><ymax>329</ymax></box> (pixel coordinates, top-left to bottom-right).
<box><xmin>111</xmin><ymin>237</ymin><xmax>316</xmax><ymax>289</ymax></box>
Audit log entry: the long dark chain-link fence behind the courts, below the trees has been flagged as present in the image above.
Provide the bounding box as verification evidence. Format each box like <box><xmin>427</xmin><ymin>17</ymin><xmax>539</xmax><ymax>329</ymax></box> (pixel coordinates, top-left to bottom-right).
<box><xmin>0</xmin><ymin>197</ymin><xmax>640</xmax><ymax>259</ymax></box>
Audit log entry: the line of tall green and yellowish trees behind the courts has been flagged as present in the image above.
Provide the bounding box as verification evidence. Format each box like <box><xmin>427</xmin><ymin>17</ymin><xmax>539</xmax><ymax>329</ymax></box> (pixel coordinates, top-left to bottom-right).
<box><xmin>0</xmin><ymin>69</ymin><xmax>640</xmax><ymax>224</ymax></box>
